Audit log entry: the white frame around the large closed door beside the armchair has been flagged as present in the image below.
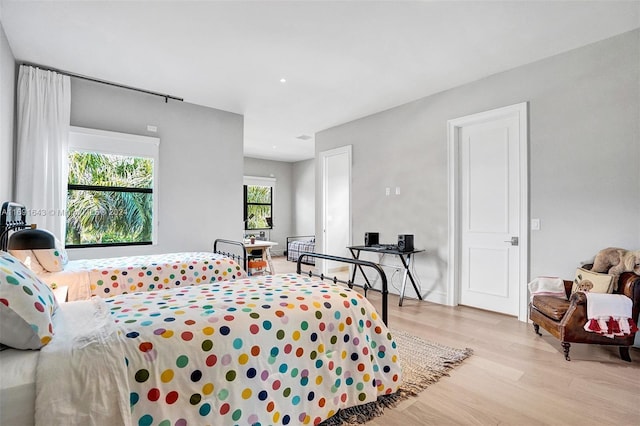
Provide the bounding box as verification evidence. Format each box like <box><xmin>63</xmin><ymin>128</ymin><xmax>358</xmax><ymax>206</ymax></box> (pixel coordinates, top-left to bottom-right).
<box><xmin>447</xmin><ymin>102</ymin><xmax>529</xmax><ymax>321</ymax></box>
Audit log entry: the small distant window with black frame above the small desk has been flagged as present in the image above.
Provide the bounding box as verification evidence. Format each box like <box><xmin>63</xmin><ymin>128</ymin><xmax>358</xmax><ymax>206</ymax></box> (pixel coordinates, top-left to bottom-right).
<box><xmin>244</xmin><ymin>176</ymin><xmax>275</xmax><ymax>230</ymax></box>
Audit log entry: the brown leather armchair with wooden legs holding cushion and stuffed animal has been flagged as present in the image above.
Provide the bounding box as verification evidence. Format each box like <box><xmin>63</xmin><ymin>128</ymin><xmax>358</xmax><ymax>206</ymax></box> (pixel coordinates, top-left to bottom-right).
<box><xmin>529</xmin><ymin>272</ymin><xmax>640</xmax><ymax>362</ymax></box>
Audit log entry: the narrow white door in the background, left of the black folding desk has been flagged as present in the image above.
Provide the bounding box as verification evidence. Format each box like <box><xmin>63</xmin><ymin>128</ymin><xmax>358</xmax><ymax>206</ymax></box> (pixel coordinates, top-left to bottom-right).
<box><xmin>320</xmin><ymin>145</ymin><xmax>351</xmax><ymax>274</ymax></box>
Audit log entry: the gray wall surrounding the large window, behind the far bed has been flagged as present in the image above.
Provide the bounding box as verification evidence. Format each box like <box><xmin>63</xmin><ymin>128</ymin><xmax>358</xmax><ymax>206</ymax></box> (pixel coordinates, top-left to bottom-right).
<box><xmin>69</xmin><ymin>78</ymin><xmax>243</xmax><ymax>259</ymax></box>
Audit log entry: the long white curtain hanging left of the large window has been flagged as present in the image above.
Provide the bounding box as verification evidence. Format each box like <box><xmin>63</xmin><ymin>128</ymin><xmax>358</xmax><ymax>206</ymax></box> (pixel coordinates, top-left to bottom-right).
<box><xmin>15</xmin><ymin>65</ymin><xmax>71</xmax><ymax>241</ymax></box>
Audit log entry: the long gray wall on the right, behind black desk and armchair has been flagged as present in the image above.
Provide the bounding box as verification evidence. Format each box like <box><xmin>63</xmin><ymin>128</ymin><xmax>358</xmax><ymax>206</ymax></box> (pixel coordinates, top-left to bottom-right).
<box><xmin>316</xmin><ymin>30</ymin><xmax>640</xmax><ymax>298</ymax></box>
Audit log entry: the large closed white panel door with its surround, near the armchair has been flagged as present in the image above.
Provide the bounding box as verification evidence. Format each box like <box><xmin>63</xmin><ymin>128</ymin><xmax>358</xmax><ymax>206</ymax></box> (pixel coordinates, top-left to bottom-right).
<box><xmin>450</xmin><ymin>104</ymin><xmax>528</xmax><ymax>319</ymax></box>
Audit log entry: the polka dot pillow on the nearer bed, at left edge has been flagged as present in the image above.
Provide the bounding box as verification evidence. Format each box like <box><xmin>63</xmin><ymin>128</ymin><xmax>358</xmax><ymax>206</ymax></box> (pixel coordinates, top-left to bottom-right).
<box><xmin>0</xmin><ymin>252</ymin><xmax>58</xmax><ymax>349</ymax></box>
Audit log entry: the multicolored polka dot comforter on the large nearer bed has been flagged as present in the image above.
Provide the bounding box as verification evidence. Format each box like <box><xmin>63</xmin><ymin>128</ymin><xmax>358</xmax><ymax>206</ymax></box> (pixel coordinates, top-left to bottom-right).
<box><xmin>36</xmin><ymin>274</ymin><xmax>401</xmax><ymax>426</ymax></box>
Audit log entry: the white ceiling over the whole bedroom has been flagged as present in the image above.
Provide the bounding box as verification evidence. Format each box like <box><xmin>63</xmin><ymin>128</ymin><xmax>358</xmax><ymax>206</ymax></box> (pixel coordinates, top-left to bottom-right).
<box><xmin>0</xmin><ymin>0</ymin><xmax>640</xmax><ymax>161</ymax></box>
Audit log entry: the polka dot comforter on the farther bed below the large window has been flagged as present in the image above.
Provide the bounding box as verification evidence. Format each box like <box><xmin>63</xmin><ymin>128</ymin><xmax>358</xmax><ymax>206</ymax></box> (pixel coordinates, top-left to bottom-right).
<box><xmin>38</xmin><ymin>252</ymin><xmax>247</xmax><ymax>301</ymax></box>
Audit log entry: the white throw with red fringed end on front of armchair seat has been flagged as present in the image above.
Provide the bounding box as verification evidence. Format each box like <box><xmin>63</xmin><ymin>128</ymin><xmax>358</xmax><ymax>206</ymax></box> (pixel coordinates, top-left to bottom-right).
<box><xmin>584</xmin><ymin>293</ymin><xmax>638</xmax><ymax>338</ymax></box>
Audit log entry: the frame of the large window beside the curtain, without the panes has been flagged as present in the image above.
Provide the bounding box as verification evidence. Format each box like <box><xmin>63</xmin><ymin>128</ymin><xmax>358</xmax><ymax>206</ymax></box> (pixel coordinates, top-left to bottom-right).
<box><xmin>65</xmin><ymin>126</ymin><xmax>160</xmax><ymax>249</ymax></box>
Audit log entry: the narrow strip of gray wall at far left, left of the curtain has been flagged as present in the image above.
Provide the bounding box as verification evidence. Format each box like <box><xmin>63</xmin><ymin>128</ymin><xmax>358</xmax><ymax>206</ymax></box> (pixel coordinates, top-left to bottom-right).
<box><xmin>0</xmin><ymin>24</ymin><xmax>16</xmax><ymax>203</ymax></box>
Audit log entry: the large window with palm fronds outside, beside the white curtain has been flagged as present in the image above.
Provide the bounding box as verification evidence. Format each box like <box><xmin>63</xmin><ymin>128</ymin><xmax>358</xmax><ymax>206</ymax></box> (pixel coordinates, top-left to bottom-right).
<box><xmin>65</xmin><ymin>127</ymin><xmax>160</xmax><ymax>248</ymax></box>
